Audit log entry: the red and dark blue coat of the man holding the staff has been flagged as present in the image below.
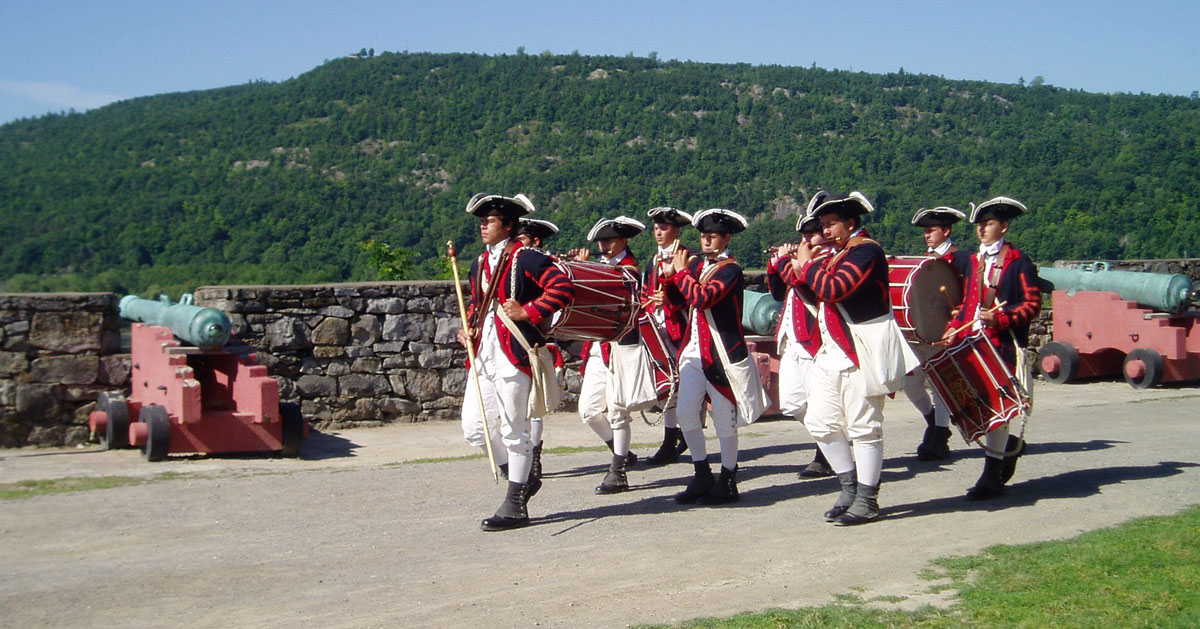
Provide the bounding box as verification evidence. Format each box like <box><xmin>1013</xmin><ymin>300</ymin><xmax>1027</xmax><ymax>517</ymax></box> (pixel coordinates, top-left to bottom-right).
<box><xmin>467</xmin><ymin>240</ymin><xmax>575</xmax><ymax>373</ymax></box>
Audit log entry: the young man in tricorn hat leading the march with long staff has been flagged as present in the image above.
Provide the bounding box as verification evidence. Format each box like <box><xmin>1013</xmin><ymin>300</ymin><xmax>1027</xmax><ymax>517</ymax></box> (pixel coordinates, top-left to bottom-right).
<box><xmin>458</xmin><ymin>193</ymin><xmax>575</xmax><ymax>531</ymax></box>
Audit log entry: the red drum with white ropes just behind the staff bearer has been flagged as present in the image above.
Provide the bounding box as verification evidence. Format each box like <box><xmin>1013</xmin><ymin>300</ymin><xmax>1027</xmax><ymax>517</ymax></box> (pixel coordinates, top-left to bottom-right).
<box><xmin>546</xmin><ymin>259</ymin><xmax>641</xmax><ymax>341</ymax></box>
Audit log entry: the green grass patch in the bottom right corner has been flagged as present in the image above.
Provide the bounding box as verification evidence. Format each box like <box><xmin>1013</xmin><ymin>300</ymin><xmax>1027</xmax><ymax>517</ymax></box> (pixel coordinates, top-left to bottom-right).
<box><xmin>643</xmin><ymin>507</ymin><xmax>1200</xmax><ymax>629</ymax></box>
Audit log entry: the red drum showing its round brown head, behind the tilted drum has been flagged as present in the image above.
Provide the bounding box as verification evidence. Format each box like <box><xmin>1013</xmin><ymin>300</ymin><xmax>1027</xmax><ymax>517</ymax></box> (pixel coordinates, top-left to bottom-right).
<box><xmin>888</xmin><ymin>256</ymin><xmax>962</xmax><ymax>345</ymax></box>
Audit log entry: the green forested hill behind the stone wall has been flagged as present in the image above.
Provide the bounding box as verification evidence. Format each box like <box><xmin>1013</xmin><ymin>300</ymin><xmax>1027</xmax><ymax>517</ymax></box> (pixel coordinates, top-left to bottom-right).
<box><xmin>0</xmin><ymin>53</ymin><xmax>1200</xmax><ymax>292</ymax></box>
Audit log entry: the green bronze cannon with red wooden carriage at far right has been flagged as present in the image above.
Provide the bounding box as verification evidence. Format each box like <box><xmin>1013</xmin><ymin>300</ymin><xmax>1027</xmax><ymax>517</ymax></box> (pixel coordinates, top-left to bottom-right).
<box><xmin>1038</xmin><ymin>263</ymin><xmax>1200</xmax><ymax>389</ymax></box>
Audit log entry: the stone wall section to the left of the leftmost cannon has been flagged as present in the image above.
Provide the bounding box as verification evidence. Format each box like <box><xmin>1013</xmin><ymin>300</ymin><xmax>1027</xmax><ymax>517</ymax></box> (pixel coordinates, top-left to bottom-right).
<box><xmin>0</xmin><ymin>293</ymin><xmax>130</xmax><ymax>448</ymax></box>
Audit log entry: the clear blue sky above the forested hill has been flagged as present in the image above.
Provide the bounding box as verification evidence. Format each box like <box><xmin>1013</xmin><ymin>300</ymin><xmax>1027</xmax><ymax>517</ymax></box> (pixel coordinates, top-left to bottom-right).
<box><xmin>0</xmin><ymin>0</ymin><xmax>1200</xmax><ymax>124</ymax></box>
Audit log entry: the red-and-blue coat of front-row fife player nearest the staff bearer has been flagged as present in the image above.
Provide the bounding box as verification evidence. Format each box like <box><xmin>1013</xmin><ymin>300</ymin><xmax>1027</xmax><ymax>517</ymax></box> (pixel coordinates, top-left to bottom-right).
<box><xmin>664</xmin><ymin>257</ymin><xmax>750</xmax><ymax>403</ymax></box>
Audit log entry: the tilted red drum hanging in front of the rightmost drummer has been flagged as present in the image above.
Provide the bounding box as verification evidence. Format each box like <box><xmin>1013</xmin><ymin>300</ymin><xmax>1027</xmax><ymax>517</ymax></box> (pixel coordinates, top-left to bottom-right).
<box><xmin>924</xmin><ymin>333</ymin><xmax>1030</xmax><ymax>443</ymax></box>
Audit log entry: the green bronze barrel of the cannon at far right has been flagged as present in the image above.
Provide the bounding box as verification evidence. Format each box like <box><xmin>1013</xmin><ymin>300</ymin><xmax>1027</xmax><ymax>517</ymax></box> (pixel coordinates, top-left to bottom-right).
<box><xmin>1038</xmin><ymin>262</ymin><xmax>1194</xmax><ymax>312</ymax></box>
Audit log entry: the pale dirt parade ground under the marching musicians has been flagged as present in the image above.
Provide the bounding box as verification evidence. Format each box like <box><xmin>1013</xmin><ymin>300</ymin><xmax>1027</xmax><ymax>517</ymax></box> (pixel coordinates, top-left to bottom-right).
<box><xmin>0</xmin><ymin>382</ymin><xmax>1200</xmax><ymax>628</ymax></box>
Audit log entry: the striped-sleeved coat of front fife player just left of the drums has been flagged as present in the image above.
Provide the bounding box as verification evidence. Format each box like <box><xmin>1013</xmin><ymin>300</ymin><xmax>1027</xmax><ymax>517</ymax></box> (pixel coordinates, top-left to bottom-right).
<box><xmin>800</xmin><ymin>232</ymin><xmax>892</xmax><ymax>367</ymax></box>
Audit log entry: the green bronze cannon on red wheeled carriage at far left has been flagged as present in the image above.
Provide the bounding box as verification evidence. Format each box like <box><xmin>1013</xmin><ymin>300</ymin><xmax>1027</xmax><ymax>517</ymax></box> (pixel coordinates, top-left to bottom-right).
<box><xmin>88</xmin><ymin>295</ymin><xmax>308</xmax><ymax>461</ymax></box>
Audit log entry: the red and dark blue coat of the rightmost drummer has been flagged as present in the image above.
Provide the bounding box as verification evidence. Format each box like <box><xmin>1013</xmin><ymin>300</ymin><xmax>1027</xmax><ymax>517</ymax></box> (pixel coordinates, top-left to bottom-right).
<box><xmin>947</xmin><ymin>244</ymin><xmax>1042</xmax><ymax>367</ymax></box>
